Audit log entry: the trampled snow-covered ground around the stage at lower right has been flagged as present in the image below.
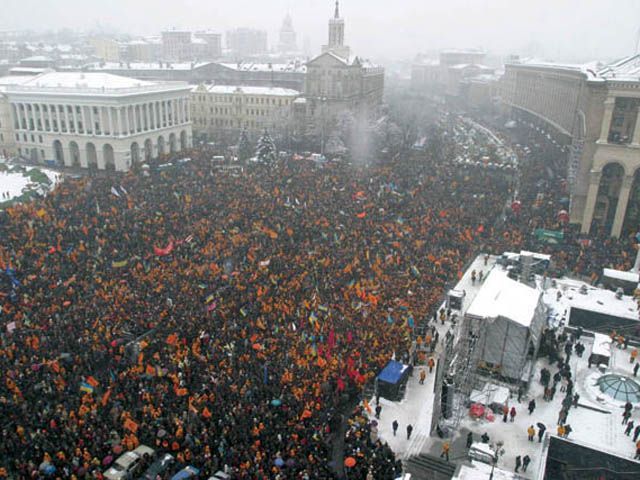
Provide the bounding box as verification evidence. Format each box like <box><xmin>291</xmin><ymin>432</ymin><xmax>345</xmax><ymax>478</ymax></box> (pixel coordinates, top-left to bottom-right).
<box><xmin>362</xmin><ymin>253</ymin><xmax>640</xmax><ymax>479</ymax></box>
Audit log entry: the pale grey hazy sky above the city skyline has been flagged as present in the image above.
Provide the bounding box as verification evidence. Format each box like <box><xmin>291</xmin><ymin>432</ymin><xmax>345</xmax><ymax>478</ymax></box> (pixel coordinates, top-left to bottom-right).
<box><xmin>0</xmin><ymin>0</ymin><xmax>640</xmax><ymax>60</ymax></box>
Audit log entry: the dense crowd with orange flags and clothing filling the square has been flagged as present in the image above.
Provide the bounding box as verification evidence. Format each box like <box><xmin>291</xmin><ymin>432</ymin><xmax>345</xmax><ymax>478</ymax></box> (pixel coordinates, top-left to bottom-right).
<box><xmin>0</xmin><ymin>110</ymin><xmax>636</xmax><ymax>479</ymax></box>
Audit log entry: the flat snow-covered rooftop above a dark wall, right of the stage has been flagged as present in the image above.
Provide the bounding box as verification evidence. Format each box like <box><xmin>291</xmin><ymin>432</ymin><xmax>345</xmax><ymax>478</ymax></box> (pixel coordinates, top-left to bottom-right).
<box><xmin>544</xmin><ymin>279</ymin><xmax>638</xmax><ymax>320</ymax></box>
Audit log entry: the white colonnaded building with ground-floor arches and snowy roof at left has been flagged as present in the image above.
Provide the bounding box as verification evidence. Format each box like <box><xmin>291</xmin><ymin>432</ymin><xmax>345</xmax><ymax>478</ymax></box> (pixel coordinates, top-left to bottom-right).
<box><xmin>0</xmin><ymin>72</ymin><xmax>191</xmax><ymax>171</ymax></box>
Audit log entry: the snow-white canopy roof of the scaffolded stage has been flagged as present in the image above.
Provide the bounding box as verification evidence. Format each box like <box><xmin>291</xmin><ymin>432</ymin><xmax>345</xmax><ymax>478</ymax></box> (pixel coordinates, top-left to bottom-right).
<box><xmin>467</xmin><ymin>268</ymin><xmax>542</xmax><ymax>327</ymax></box>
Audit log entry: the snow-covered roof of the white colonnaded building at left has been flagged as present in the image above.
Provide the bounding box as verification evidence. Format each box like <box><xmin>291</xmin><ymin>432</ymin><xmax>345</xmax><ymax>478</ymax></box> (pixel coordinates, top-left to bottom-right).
<box><xmin>6</xmin><ymin>72</ymin><xmax>188</xmax><ymax>95</ymax></box>
